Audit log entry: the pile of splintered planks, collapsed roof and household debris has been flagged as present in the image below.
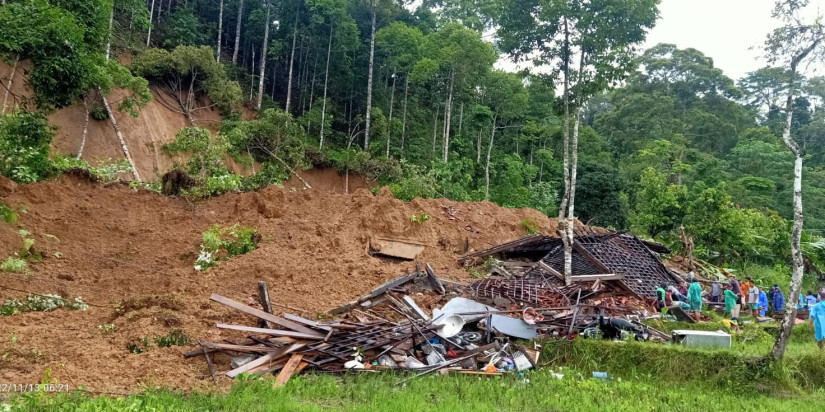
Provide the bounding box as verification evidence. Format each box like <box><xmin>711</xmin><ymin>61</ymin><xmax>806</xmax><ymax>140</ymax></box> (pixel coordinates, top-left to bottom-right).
<box><xmin>192</xmin><ymin>231</ymin><xmax>673</xmax><ymax>385</ymax></box>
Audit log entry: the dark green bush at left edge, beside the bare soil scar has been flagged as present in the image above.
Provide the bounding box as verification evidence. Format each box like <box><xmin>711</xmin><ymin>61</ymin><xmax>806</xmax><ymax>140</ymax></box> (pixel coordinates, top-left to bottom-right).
<box><xmin>0</xmin><ymin>112</ymin><xmax>55</xmax><ymax>183</ymax></box>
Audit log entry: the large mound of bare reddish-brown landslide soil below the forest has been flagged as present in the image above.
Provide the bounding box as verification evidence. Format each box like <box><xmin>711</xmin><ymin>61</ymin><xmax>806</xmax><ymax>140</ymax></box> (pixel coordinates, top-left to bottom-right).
<box><xmin>0</xmin><ymin>176</ymin><xmax>555</xmax><ymax>392</ymax></box>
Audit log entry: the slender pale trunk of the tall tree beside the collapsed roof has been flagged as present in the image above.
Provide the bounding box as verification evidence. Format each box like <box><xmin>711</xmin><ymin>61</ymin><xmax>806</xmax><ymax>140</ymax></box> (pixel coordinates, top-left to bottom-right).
<box><xmin>558</xmin><ymin>19</ymin><xmax>573</xmax><ymax>285</ymax></box>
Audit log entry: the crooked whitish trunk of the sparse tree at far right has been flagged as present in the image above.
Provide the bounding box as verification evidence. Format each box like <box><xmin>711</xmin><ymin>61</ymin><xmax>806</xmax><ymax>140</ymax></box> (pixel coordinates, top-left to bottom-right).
<box><xmin>771</xmin><ymin>66</ymin><xmax>805</xmax><ymax>359</ymax></box>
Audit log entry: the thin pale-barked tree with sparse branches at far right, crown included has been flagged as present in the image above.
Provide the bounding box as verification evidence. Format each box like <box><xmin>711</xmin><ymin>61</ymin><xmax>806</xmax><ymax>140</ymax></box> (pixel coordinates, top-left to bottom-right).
<box><xmin>765</xmin><ymin>0</ymin><xmax>825</xmax><ymax>359</ymax></box>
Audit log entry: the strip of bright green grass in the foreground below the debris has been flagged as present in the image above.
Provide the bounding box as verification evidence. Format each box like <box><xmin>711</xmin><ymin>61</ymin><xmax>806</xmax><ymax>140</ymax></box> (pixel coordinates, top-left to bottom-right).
<box><xmin>6</xmin><ymin>365</ymin><xmax>825</xmax><ymax>412</ymax></box>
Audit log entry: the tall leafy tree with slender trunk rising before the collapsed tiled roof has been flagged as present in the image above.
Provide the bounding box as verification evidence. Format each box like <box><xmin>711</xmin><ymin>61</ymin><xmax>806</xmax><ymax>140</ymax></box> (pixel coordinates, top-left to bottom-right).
<box><xmin>494</xmin><ymin>0</ymin><xmax>659</xmax><ymax>284</ymax></box>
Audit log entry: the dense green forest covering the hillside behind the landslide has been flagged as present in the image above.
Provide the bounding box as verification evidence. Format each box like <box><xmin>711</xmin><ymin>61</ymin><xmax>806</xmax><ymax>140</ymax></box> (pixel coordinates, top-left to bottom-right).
<box><xmin>0</xmin><ymin>0</ymin><xmax>825</xmax><ymax>272</ymax></box>
